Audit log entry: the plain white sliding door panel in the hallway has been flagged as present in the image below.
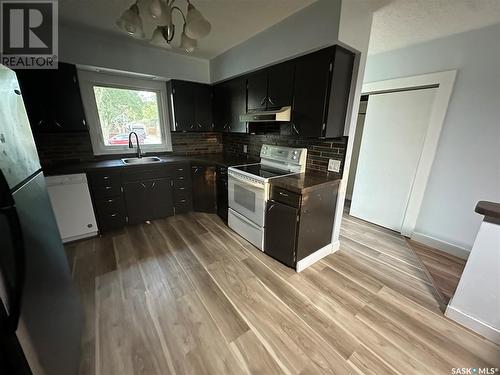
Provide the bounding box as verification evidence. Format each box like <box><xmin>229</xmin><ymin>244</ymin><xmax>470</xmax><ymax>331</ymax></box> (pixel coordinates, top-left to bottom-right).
<box><xmin>350</xmin><ymin>88</ymin><xmax>437</xmax><ymax>232</ymax></box>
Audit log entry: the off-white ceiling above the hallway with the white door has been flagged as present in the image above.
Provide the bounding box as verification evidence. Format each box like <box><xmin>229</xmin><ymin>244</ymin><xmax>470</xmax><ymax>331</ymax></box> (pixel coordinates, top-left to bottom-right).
<box><xmin>370</xmin><ymin>0</ymin><xmax>500</xmax><ymax>54</ymax></box>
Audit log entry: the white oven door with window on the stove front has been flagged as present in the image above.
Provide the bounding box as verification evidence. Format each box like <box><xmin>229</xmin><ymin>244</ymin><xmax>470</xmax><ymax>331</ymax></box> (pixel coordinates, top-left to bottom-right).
<box><xmin>228</xmin><ymin>175</ymin><xmax>266</xmax><ymax>227</ymax></box>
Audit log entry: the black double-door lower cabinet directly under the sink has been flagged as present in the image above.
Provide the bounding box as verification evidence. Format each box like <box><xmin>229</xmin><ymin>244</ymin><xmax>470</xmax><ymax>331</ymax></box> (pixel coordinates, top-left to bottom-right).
<box><xmin>123</xmin><ymin>178</ymin><xmax>174</xmax><ymax>224</ymax></box>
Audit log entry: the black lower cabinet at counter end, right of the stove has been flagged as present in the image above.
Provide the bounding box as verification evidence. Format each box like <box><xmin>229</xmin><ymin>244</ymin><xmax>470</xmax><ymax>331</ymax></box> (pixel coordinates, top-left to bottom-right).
<box><xmin>264</xmin><ymin>183</ymin><xmax>338</xmax><ymax>268</ymax></box>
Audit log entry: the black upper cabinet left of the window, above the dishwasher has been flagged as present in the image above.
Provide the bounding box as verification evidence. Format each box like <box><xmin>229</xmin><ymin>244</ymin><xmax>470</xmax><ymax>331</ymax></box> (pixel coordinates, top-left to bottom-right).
<box><xmin>16</xmin><ymin>62</ymin><xmax>88</xmax><ymax>133</ymax></box>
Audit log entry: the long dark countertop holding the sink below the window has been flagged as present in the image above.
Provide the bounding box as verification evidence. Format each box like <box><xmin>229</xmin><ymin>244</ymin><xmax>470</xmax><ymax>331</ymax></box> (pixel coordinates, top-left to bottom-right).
<box><xmin>43</xmin><ymin>154</ymin><xmax>259</xmax><ymax>176</ymax></box>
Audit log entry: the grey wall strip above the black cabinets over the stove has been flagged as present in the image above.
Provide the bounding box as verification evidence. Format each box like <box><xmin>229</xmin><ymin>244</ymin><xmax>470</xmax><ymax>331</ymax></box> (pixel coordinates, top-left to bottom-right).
<box><xmin>210</xmin><ymin>0</ymin><xmax>341</xmax><ymax>82</ymax></box>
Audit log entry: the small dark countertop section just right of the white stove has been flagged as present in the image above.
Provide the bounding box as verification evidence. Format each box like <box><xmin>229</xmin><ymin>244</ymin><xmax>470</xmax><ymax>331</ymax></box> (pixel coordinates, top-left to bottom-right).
<box><xmin>269</xmin><ymin>171</ymin><xmax>342</xmax><ymax>194</ymax></box>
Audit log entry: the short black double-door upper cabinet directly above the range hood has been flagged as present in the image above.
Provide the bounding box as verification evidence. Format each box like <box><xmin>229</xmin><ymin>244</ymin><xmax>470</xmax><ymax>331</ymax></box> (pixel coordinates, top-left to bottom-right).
<box><xmin>247</xmin><ymin>61</ymin><xmax>294</xmax><ymax>111</ymax></box>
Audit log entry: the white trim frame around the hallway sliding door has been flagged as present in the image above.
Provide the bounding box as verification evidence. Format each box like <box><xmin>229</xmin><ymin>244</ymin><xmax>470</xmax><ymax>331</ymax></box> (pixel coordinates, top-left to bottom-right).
<box><xmin>360</xmin><ymin>70</ymin><xmax>457</xmax><ymax>237</ymax></box>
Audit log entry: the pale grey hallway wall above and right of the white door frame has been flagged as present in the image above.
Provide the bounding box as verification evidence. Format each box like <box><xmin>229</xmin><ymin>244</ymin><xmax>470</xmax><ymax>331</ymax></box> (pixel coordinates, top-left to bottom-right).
<box><xmin>365</xmin><ymin>24</ymin><xmax>500</xmax><ymax>250</ymax></box>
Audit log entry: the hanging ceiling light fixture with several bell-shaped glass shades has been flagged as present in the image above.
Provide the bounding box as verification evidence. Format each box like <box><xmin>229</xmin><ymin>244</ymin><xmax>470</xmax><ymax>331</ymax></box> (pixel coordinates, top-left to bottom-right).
<box><xmin>116</xmin><ymin>0</ymin><xmax>211</xmax><ymax>53</ymax></box>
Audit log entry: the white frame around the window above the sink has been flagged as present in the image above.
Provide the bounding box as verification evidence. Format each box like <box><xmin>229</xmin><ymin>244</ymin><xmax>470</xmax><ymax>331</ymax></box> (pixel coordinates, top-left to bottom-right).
<box><xmin>78</xmin><ymin>69</ymin><xmax>172</xmax><ymax>155</ymax></box>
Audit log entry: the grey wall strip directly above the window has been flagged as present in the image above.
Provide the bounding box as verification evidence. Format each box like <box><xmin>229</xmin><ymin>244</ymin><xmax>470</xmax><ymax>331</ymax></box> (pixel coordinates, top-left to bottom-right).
<box><xmin>59</xmin><ymin>25</ymin><xmax>210</xmax><ymax>83</ymax></box>
